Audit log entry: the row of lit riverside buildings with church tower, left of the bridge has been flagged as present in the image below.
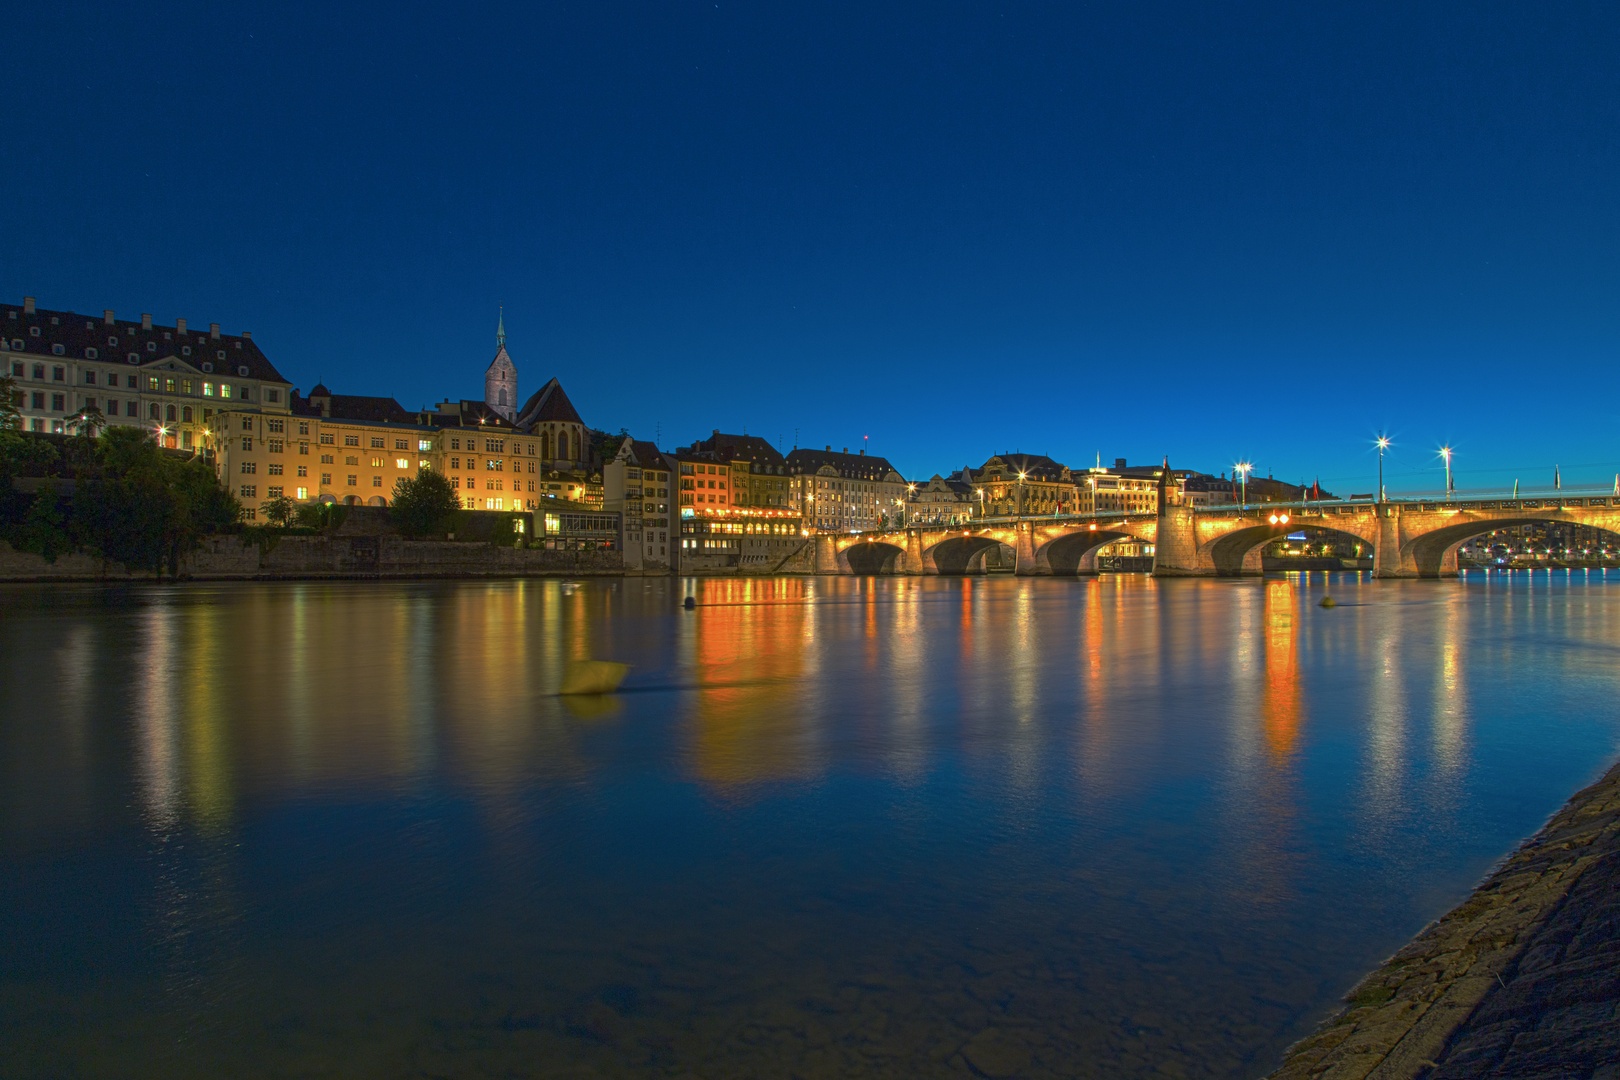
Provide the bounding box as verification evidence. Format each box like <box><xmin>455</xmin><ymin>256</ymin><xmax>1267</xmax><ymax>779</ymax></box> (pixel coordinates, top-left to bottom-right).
<box><xmin>0</xmin><ymin>298</ymin><xmax>1254</xmax><ymax>572</ymax></box>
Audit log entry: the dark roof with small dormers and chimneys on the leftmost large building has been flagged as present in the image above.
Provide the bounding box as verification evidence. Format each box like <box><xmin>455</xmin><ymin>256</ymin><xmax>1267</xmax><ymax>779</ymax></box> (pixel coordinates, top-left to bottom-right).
<box><xmin>0</xmin><ymin>304</ymin><xmax>287</xmax><ymax>384</ymax></box>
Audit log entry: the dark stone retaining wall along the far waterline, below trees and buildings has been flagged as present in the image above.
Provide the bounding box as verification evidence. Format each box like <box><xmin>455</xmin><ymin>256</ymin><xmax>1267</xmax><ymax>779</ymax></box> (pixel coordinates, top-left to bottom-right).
<box><xmin>0</xmin><ymin>534</ymin><xmax>625</xmax><ymax>581</ymax></box>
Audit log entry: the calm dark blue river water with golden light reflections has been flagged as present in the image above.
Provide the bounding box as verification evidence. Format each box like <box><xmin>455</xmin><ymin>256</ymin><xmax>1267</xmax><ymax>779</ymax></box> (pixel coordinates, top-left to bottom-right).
<box><xmin>0</xmin><ymin>573</ymin><xmax>1620</xmax><ymax>1078</ymax></box>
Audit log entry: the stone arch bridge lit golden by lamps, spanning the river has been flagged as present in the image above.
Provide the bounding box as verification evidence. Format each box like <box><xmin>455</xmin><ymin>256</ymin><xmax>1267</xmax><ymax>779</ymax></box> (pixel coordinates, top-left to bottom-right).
<box><xmin>815</xmin><ymin>491</ymin><xmax>1620</xmax><ymax>578</ymax></box>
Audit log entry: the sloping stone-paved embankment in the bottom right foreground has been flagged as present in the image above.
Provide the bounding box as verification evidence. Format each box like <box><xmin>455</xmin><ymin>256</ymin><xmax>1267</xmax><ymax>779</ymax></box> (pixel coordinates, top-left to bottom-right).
<box><xmin>1272</xmin><ymin>766</ymin><xmax>1620</xmax><ymax>1080</ymax></box>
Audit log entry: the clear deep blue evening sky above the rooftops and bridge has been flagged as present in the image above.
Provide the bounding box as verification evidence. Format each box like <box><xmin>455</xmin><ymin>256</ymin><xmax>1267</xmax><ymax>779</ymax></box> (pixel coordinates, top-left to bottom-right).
<box><xmin>9</xmin><ymin>0</ymin><xmax>1620</xmax><ymax>492</ymax></box>
